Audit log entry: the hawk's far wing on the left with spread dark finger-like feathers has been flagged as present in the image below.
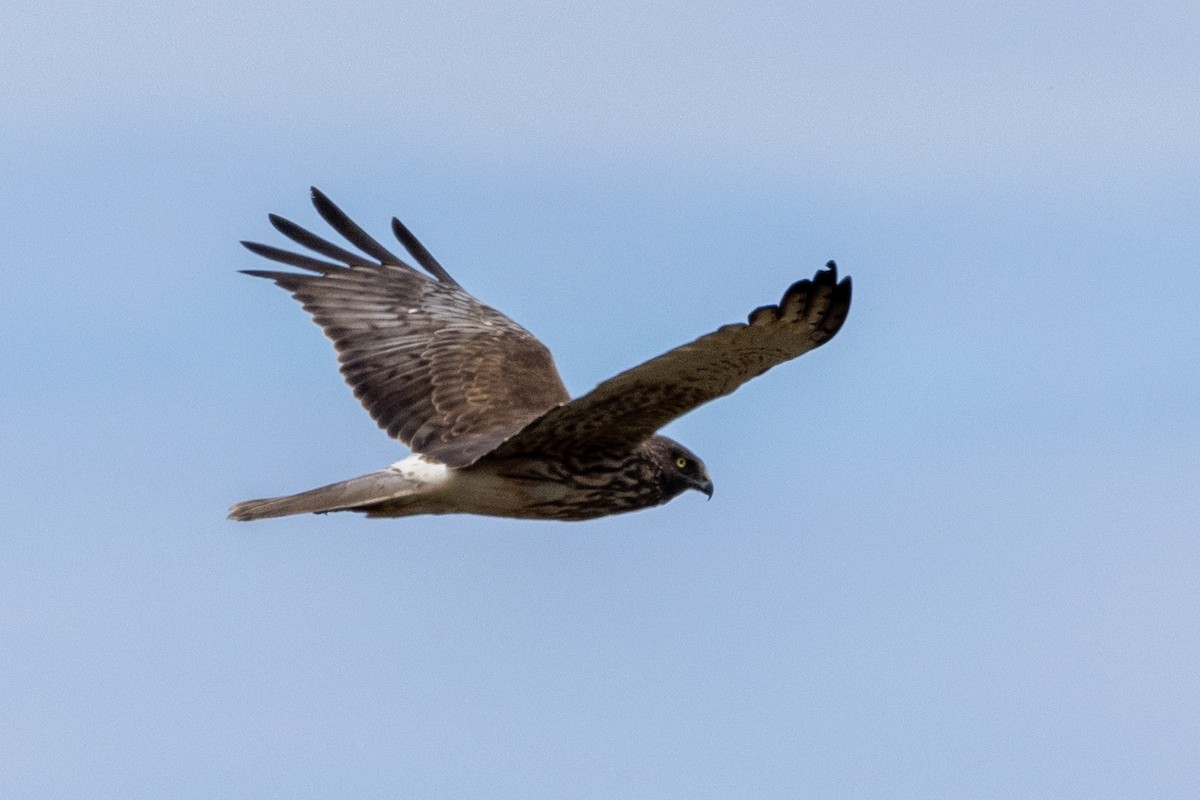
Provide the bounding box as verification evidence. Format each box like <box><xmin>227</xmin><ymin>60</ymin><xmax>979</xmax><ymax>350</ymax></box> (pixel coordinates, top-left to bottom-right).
<box><xmin>242</xmin><ymin>188</ymin><xmax>570</xmax><ymax>467</ymax></box>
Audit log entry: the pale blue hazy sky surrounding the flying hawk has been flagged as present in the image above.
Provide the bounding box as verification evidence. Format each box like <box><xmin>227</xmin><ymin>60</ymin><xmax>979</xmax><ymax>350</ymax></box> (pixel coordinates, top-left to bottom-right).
<box><xmin>0</xmin><ymin>0</ymin><xmax>1200</xmax><ymax>800</ymax></box>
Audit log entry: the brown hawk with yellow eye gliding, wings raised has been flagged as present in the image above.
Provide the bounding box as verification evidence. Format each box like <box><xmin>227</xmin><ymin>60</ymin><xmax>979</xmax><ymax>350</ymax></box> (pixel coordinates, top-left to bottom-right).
<box><xmin>229</xmin><ymin>188</ymin><xmax>851</xmax><ymax>519</ymax></box>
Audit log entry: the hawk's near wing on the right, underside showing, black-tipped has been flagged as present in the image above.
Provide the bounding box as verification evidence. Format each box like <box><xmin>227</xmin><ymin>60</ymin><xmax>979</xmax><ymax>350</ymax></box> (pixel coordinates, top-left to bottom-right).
<box><xmin>497</xmin><ymin>261</ymin><xmax>851</xmax><ymax>456</ymax></box>
